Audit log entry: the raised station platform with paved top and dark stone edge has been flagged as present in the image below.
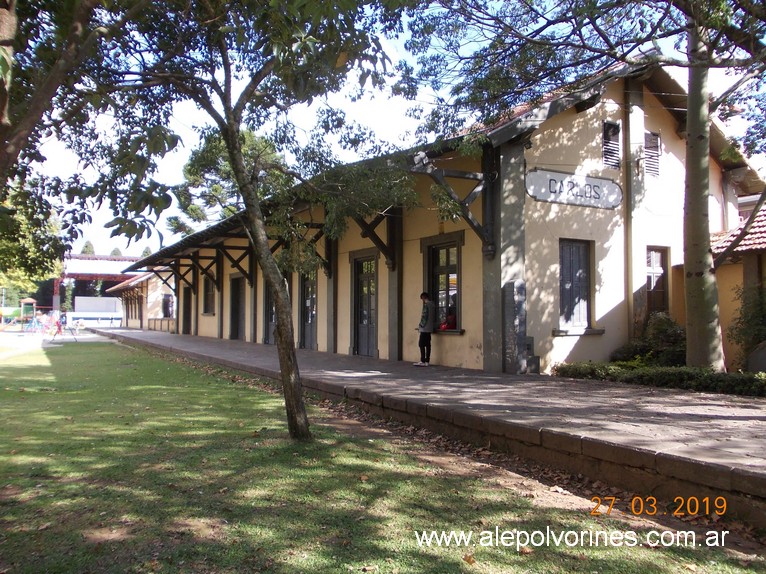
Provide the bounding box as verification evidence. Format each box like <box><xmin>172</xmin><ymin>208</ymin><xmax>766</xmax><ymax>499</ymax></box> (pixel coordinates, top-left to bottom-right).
<box><xmin>97</xmin><ymin>329</ymin><xmax>766</xmax><ymax>526</ymax></box>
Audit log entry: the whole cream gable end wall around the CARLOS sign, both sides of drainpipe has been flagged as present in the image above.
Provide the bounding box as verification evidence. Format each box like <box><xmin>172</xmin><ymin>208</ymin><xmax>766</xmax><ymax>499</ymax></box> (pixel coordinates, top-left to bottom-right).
<box><xmin>525</xmin><ymin>77</ymin><xmax>730</xmax><ymax>371</ymax></box>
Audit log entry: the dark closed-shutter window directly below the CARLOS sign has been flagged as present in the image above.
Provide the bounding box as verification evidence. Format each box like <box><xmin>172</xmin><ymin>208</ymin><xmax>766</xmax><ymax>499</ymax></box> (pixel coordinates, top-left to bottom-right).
<box><xmin>559</xmin><ymin>239</ymin><xmax>591</xmax><ymax>330</ymax></box>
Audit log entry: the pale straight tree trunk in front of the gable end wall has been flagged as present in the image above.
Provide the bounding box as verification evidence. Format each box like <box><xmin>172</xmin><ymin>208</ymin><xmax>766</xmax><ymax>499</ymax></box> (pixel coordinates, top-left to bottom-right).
<box><xmin>684</xmin><ymin>22</ymin><xmax>725</xmax><ymax>371</ymax></box>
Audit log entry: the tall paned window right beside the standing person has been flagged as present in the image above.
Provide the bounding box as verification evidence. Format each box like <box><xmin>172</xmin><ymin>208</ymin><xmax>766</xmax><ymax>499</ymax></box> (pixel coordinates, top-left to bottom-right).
<box><xmin>421</xmin><ymin>231</ymin><xmax>464</xmax><ymax>332</ymax></box>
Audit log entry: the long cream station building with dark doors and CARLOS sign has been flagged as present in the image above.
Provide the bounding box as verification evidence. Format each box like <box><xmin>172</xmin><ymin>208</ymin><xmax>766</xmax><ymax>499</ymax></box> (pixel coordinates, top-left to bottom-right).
<box><xmin>120</xmin><ymin>65</ymin><xmax>764</xmax><ymax>372</ymax></box>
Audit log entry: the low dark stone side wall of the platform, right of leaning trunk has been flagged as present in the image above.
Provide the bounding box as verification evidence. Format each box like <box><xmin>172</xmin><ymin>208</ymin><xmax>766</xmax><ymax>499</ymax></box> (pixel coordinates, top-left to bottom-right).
<box><xmin>303</xmin><ymin>378</ymin><xmax>766</xmax><ymax>528</ymax></box>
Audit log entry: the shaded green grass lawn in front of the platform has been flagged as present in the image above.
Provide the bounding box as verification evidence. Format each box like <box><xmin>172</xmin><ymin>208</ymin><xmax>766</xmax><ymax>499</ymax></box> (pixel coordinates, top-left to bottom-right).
<box><xmin>0</xmin><ymin>343</ymin><xmax>766</xmax><ymax>574</ymax></box>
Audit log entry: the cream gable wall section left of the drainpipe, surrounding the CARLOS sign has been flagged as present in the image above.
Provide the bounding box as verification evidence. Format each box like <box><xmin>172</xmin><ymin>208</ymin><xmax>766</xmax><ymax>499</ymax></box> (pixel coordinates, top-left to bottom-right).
<box><xmin>525</xmin><ymin>81</ymin><xmax>632</xmax><ymax>371</ymax></box>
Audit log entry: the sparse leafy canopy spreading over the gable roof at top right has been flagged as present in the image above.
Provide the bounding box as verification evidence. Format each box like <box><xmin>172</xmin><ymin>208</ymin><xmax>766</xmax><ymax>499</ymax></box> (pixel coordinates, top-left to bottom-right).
<box><xmin>400</xmin><ymin>0</ymin><xmax>766</xmax><ymax>145</ymax></box>
